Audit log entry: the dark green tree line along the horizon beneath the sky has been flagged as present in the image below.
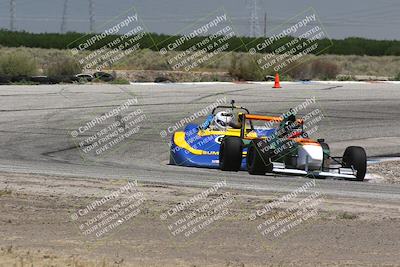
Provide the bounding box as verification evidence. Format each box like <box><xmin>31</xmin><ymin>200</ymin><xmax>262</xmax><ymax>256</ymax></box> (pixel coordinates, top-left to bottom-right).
<box><xmin>0</xmin><ymin>30</ymin><xmax>400</xmax><ymax>56</ymax></box>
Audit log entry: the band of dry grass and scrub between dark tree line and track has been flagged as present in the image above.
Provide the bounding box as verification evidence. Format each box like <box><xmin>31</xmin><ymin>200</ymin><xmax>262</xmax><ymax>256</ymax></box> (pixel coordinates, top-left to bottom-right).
<box><xmin>0</xmin><ymin>47</ymin><xmax>400</xmax><ymax>82</ymax></box>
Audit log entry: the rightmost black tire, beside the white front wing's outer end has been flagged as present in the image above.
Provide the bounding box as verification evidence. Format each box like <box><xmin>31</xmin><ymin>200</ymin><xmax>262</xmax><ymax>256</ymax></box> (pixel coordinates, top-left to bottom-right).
<box><xmin>342</xmin><ymin>146</ymin><xmax>367</xmax><ymax>181</ymax></box>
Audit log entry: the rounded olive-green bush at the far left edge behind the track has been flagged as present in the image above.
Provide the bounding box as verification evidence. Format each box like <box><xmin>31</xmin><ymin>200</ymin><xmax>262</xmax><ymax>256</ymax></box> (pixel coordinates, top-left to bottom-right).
<box><xmin>0</xmin><ymin>51</ymin><xmax>38</xmax><ymax>76</ymax></box>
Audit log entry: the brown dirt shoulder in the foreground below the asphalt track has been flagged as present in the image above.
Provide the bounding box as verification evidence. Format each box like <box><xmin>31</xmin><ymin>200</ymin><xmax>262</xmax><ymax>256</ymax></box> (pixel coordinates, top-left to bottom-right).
<box><xmin>0</xmin><ymin>173</ymin><xmax>400</xmax><ymax>266</ymax></box>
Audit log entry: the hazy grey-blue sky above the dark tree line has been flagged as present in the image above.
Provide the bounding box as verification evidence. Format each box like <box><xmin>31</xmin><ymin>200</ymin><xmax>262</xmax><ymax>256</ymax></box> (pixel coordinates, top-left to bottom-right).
<box><xmin>0</xmin><ymin>0</ymin><xmax>400</xmax><ymax>40</ymax></box>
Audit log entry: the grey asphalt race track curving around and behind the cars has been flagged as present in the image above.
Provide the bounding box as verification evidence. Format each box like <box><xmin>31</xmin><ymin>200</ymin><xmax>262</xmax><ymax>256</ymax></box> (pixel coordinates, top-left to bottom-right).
<box><xmin>0</xmin><ymin>83</ymin><xmax>400</xmax><ymax>200</ymax></box>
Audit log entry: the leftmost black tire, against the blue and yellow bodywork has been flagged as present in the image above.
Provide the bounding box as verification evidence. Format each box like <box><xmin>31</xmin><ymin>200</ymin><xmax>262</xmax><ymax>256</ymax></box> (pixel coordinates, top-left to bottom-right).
<box><xmin>219</xmin><ymin>136</ymin><xmax>243</xmax><ymax>172</ymax></box>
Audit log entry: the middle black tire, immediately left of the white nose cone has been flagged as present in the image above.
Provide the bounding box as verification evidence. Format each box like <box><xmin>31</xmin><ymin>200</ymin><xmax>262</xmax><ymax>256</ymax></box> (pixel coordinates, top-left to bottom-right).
<box><xmin>246</xmin><ymin>140</ymin><xmax>273</xmax><ymax>175</ymax></box>
